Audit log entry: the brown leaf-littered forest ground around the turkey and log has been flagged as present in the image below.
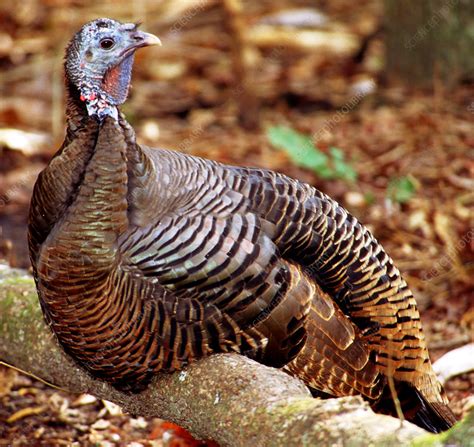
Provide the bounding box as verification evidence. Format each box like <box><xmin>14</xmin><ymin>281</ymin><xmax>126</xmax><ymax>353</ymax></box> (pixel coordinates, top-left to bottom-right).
<box><xmin>0</xmin><ymin>0</ymin><xmax>474</xmax><ymax>447</ymax></box>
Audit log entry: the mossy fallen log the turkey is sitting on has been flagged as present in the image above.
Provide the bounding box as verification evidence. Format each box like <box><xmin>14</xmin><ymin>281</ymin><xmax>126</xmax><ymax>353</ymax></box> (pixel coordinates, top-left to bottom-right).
<box><xmin>0</xmin><ymin>265</ymin><xmax>450</xmax><ymax>446</ymax></box>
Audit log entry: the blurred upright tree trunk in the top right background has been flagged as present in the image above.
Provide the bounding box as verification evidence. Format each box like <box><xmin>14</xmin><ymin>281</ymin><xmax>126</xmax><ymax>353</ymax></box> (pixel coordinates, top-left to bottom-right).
<box><xmin>385</xmin><ymin>0</ymin><xmax>474</xmax><ymax>86</ymax></box>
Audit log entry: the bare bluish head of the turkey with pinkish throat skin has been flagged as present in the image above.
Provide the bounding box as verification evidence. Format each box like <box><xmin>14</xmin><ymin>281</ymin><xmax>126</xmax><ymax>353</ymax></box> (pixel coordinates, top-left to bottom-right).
<box><xmin>65</xmin><ymin>19</ymin><xmax>161</xmax><ymax>121</ymax></box>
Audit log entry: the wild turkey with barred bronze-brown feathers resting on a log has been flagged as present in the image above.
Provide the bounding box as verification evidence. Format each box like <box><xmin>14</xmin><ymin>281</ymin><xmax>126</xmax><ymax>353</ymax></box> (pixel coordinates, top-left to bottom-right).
<box><xmin>29</xmin><ymin>19</ymin><xmax>455</xmax><ymax>432</ymax></box>
